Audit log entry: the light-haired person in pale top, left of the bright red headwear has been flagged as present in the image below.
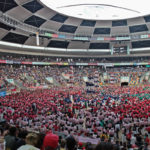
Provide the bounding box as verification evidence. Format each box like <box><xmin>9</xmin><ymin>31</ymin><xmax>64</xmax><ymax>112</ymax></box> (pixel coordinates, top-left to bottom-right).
<box><xmin>17</xmin><ymin>133</ymin><xmax>40</xmax><ymax>150</ymax></box>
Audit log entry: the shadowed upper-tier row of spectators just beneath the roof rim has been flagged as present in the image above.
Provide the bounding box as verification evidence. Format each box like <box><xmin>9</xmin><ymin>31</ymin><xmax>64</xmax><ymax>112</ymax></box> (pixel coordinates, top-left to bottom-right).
<box><xmin>0</xmin><ymin>53</ymin><xmax>150</xmax><ymax>63</ymax></box>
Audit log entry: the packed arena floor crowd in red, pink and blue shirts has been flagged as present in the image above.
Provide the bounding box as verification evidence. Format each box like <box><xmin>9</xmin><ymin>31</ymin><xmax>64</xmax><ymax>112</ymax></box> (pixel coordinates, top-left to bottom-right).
<box><xmin>0</xmin><ymin>86</ymin><xmax>150</xmax><ymax>149</ymax></box>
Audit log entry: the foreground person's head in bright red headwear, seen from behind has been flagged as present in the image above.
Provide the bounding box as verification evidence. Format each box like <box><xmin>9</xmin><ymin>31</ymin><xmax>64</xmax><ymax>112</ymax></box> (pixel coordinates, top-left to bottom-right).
<box><xmin>42</xmin><ymin>132</ymin><xmax>59</xmax><ymax>150</ymax></box>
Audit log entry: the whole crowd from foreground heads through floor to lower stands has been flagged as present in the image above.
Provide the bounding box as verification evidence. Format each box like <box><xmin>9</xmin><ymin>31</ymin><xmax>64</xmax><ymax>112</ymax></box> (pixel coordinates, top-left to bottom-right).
<box><xmin>0</xmin><ymin>56</ymin><xmax>150</xmax><ymax>150</ymax></box>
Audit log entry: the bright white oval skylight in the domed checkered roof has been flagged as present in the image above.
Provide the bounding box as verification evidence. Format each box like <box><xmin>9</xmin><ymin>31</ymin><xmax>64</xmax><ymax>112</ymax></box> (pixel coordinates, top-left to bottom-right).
<box><xmin>41</xmin><ymin>0</ymin><xmax>150</xmax><ymax>20</ymax></box>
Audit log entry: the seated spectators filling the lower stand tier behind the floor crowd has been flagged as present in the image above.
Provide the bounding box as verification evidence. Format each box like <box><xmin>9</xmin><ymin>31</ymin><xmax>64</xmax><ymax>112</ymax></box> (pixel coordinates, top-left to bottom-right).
<box><xmin>0</xmin><ymin>65</ymin><xmax>149</xmax><ymax>90</ymax></box>
